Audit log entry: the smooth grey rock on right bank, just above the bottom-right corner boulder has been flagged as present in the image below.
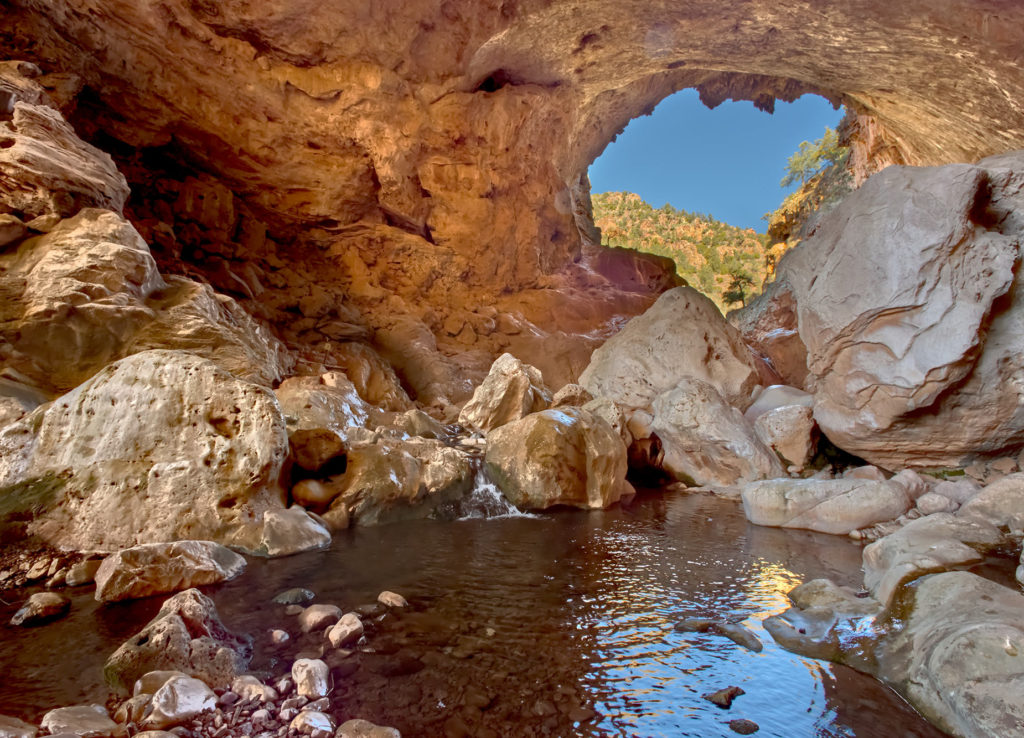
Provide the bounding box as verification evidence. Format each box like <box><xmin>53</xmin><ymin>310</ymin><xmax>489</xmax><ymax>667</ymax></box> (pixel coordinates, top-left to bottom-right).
<box><xmin>863</xmin><ymin>511</ymin><xmax>1004</xmax><ymax>604</ymax></box>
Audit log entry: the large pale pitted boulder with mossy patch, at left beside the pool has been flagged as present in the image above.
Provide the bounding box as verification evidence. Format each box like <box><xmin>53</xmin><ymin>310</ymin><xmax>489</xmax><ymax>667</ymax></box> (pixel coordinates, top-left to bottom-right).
<box><xmin>0</xmin><ymin>351</ymin><xmax>288</xmax><ymax>551</ymax></box>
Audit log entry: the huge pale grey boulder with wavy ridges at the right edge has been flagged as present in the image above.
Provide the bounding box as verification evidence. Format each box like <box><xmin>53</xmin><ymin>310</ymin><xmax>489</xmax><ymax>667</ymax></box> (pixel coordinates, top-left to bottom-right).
<box><xmin>779</xmin><ymin>153</ymin><xmax>1024</xmax><ymax>469</ymax></box>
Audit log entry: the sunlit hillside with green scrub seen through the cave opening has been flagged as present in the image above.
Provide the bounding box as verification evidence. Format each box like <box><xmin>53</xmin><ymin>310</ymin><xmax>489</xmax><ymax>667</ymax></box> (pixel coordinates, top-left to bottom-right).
<box><xmin>591</xmin><ymin>192</ymin><xmax>768</xmax><ymax>312</ymax></box>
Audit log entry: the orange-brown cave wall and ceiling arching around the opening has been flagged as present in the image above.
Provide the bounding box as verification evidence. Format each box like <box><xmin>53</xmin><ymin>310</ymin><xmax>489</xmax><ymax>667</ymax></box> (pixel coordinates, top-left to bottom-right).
<box><xmin>0</xmin><ymin>0</ymin><xmax>1024</xmax><ymax>397</ymax></box>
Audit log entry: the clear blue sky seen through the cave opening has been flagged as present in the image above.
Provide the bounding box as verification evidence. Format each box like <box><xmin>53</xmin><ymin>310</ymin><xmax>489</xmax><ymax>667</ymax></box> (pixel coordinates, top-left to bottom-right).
<box><xmin>590</xmin><ymin>89</ymin><xmax>843</xmax><ymax>231</ymax></box>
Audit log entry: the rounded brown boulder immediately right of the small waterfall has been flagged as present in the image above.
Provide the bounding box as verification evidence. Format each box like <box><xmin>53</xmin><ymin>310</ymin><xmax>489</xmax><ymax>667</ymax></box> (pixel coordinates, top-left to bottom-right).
<box><xmin>485</xmin><ymin>407</ymin><xmax>633</xmax><ymax>510</ymax></box>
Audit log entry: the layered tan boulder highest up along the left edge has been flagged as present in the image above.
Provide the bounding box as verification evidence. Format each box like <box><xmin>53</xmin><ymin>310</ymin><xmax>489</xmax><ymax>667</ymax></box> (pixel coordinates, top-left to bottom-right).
<box><xmin>0</xmin><ymin>100</ymin><xmax>128</xmax><ymax>217</ymax></box>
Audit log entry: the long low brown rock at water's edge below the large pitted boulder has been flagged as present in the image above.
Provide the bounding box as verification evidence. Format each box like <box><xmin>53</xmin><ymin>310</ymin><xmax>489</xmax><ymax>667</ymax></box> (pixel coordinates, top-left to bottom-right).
<box><xmin>96</xmin><ymin>540</ymin><xmax>246</xmax><ymax>602</ymax></box>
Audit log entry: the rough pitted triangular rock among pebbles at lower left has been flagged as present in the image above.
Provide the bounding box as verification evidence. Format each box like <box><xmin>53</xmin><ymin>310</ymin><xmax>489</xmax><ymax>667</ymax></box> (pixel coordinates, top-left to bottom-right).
<box><xmin>103</xmin><ymin>590</ymin><xmax>252</xmax><ymax>693</ymax></box>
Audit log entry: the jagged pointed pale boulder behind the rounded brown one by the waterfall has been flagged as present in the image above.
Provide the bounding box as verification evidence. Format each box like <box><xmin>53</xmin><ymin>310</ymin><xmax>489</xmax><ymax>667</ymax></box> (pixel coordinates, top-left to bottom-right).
<box><xmin>459</xmin><ymin>353</ymin><xmax>551</xmax><ymax>433</ymax></box>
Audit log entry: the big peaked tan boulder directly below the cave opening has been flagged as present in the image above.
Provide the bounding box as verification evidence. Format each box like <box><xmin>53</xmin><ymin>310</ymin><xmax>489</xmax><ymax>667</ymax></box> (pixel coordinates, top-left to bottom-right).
<box><xmin>580</xmin><ymin>287</ymin><xmax>758</xmax><ymax>409</ymax></box>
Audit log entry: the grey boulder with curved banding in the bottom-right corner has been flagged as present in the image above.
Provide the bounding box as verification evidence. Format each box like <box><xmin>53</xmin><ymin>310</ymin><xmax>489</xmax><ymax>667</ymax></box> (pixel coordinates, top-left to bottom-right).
<box><xmin>878</xmin><ymin>571</ymin><xmax>1024</xmax><ymax>738</ymax></box>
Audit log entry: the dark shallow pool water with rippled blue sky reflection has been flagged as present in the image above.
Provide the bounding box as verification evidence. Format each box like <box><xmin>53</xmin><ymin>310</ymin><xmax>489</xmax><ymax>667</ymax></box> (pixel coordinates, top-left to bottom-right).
<box><xmin>0</xmin><ymin>495</ymin><xmax>942</xmax><ymax>738</ymax></box>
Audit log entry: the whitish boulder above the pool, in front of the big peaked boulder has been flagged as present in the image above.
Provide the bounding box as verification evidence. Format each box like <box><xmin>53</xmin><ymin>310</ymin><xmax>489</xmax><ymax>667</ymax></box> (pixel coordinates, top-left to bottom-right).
<box><xmin>650</xmin><ymin>378</ymin><xmax>785</xmax><ymax>486</ymax></box>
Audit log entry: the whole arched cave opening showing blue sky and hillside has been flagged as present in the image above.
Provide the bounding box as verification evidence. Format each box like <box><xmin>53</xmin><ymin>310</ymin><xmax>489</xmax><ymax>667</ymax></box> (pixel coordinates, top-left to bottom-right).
<box><xmin>589</xmin><ymin>89</ymin><xmax>850</xmax><ymax>312</ymax></box>
